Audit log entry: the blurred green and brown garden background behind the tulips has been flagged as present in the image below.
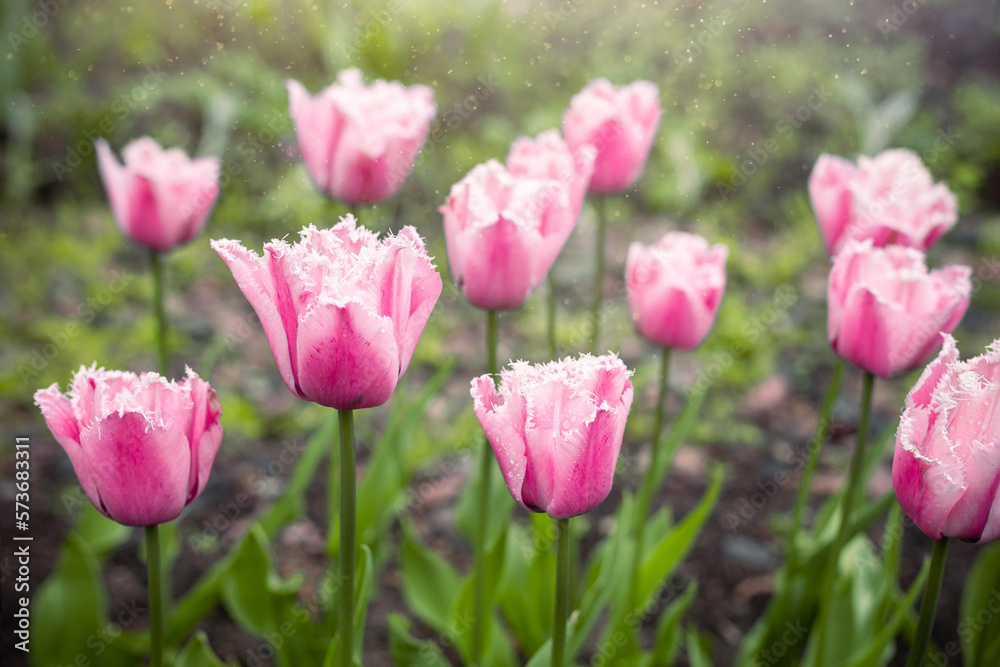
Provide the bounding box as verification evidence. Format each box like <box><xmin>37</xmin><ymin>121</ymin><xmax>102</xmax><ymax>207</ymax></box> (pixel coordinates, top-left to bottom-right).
<box><xmin>0</xmin><ymin>0</ymin><xmax>1000</xmax><ymax>664</ymax></box>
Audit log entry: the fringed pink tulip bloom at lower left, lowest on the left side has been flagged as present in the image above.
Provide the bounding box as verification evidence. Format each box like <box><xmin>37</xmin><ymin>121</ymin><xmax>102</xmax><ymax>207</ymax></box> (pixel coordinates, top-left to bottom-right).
<box><xmin>35</xmin><ymin>364</ymin><xmax>222</xmax><ymax>526</ymax></box>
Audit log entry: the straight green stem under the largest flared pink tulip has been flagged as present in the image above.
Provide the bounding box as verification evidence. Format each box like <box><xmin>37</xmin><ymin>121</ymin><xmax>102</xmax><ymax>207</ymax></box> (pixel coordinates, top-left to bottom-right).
<box><xmin>337</xmin><ymin>410</ymin><xmax>357</xmax><ymax>667</ymax></box>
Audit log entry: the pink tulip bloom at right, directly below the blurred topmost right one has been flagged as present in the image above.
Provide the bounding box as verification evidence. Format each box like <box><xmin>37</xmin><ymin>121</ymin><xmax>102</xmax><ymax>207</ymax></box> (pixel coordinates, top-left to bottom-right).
<box><xmin>827</xmin><ymin>240</ymin><xmax>972</xmax><ymax>378</ymax></box>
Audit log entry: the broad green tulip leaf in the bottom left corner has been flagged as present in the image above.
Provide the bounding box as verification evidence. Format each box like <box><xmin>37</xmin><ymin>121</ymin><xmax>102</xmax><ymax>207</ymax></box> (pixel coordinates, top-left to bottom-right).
<box><xmin>32</xmin><ymin>532</ymin><xmax>138</xmax><ymax>667</ymax></box>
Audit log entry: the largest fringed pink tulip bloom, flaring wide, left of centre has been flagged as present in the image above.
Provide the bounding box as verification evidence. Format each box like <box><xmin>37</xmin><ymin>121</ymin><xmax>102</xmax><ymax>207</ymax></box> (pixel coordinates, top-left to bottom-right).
<box><xmin>211</xmin><ymin>215</ymin><xmax>441</xmax><ymax>410</ymax></box>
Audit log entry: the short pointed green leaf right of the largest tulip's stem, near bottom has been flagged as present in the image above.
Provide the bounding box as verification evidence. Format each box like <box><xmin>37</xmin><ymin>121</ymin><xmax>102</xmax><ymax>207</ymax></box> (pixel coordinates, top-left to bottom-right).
<box><xmin>399</xmin><ymin>527</ymin><xmax>462</xmax><ymax>632</ymax></box>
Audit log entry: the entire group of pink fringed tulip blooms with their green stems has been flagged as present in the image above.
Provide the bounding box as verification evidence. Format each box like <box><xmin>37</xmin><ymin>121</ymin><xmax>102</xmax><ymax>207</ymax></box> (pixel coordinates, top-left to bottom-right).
<box><xmin>35</xmin><ymin>64</ymin><xmax>1000</xmax><ymax>666</ymax></box>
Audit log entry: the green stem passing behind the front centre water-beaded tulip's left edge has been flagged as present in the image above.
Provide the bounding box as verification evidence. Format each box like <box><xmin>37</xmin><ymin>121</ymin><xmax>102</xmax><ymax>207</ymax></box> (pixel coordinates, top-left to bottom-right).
<box><xmin>472</xmin><ymin>310</ymin><xmax>499</xmax><ymax>665</ymax></box>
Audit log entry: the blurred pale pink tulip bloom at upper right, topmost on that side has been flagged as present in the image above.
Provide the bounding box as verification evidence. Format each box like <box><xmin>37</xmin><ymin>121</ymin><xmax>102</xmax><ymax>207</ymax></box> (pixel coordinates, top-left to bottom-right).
<box><xmin>809</xmin><ymin>149</ymin><xmax>958</xmax><ymax>255</ymax></box>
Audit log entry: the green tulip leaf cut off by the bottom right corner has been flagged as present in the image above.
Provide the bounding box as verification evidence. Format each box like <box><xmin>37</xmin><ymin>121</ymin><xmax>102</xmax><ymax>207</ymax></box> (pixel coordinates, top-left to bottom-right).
<box><xmin>958</xmin><ymin>542</ymin><xmax>1000</xmax><ymax>667</ymax></box>
